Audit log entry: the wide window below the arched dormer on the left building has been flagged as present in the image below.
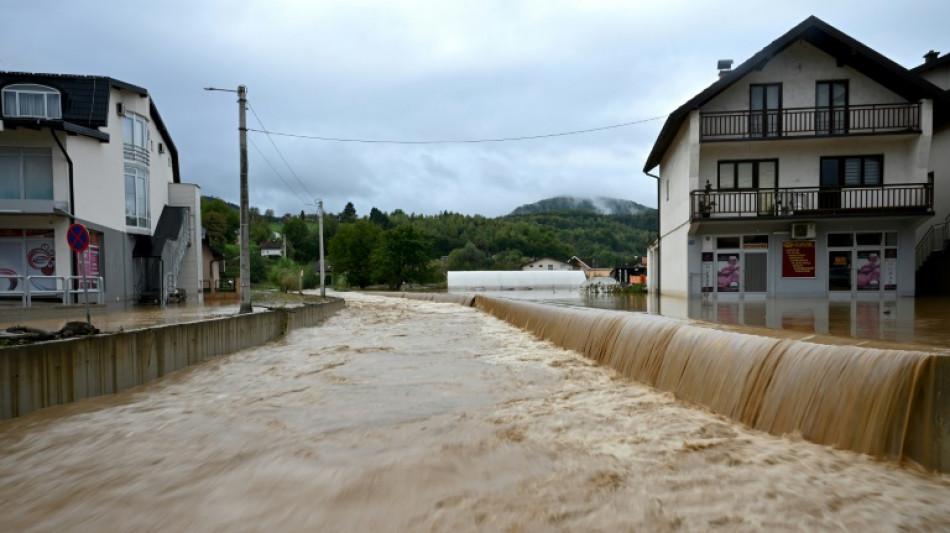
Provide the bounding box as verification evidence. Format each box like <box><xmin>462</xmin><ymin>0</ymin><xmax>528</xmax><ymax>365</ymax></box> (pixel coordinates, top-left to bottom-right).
<box><xmin>0</xmin><ymin>148</ymin><xmax>53</xmax><ymax>200</ymax></box>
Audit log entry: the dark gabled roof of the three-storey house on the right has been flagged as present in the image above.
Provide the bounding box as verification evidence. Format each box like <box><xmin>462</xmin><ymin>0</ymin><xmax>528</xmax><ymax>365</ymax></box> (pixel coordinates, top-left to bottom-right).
<box><xmin>643</xmin><ymin>16</ymin><xmax>950</xmax><ymax>172</ymax></box>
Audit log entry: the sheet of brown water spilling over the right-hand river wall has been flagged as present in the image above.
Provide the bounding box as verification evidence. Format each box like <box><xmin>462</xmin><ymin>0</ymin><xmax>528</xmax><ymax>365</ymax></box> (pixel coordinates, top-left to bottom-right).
<box><xmin>475</xmin><ymin>296</ymin><xmax>950</xmax><ymax>472</ymax></box>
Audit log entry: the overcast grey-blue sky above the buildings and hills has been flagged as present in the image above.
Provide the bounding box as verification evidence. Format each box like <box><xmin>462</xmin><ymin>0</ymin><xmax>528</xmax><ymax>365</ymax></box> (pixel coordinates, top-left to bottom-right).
<box><xmin>0</xmin><ymin>0</ymin><xmax>950</xmax><ymax>216</ymax></box>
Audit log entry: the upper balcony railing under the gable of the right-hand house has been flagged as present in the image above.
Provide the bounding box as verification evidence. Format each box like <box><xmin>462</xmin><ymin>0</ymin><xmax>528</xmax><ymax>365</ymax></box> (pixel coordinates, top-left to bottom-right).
<box><xmin>699</xmin><ymin>104</ymin><xmax>920</xmax><ymax>141</ymax></box>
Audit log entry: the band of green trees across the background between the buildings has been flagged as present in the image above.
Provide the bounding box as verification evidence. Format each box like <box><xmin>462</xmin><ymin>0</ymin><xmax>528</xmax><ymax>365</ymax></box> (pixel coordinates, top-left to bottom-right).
<box><xmin>202</xmin><ymin>198</ymin><xmax>656</xmax><ymax>289</ymax></box>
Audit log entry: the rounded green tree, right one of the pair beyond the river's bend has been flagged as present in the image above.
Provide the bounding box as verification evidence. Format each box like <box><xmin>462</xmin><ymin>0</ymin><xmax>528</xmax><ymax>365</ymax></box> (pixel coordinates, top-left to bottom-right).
<box><xmin>373</xmin><ymin>224</ymin><xmax>432</xmax><ymax>290</ymax></box>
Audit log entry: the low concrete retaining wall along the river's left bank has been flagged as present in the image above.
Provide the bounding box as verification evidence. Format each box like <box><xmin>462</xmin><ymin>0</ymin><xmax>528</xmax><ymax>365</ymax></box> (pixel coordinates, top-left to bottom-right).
<box><xmin>0</xmin><ymin>299</ymin><xmax>344</xmax><ymax>419</ymax></box>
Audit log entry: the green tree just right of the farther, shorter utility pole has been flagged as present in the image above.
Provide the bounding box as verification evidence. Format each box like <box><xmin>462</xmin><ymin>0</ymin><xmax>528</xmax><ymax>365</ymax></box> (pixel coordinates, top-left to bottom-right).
<box><xmin>328</xmin><ymin>220</ymin><xmax>382</xmax><ymax>289</ymax></box>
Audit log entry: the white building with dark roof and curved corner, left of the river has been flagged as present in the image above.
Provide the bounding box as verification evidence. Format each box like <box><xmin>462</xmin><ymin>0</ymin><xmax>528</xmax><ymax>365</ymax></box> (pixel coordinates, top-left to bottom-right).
<box><xmin>0</xmin><ymin>72</ymin><xmax>202</xmax><ymax>303</ymax></box>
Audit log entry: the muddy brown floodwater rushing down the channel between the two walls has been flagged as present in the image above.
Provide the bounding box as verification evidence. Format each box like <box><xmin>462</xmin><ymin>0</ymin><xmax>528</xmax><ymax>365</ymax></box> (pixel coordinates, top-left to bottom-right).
<box><xmin>0</xmin><ymin>294</ymin><xmax>950</xmax><ymax>532</ymax></box>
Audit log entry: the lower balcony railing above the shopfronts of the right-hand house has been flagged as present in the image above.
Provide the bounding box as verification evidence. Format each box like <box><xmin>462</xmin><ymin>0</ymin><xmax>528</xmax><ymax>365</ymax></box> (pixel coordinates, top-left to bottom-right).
<box><xmin>690</xmin><ymin>183</ymin><xmax>933</xmax><ymax>221</ymax></box>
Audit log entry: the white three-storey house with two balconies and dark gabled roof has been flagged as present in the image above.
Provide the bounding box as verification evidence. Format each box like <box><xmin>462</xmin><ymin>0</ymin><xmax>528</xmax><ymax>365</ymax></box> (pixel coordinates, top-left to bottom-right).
<box><xmin>644</xmin><ymin>17</ymin><xmax>950</xmax><ymax>300</ymax></box>
